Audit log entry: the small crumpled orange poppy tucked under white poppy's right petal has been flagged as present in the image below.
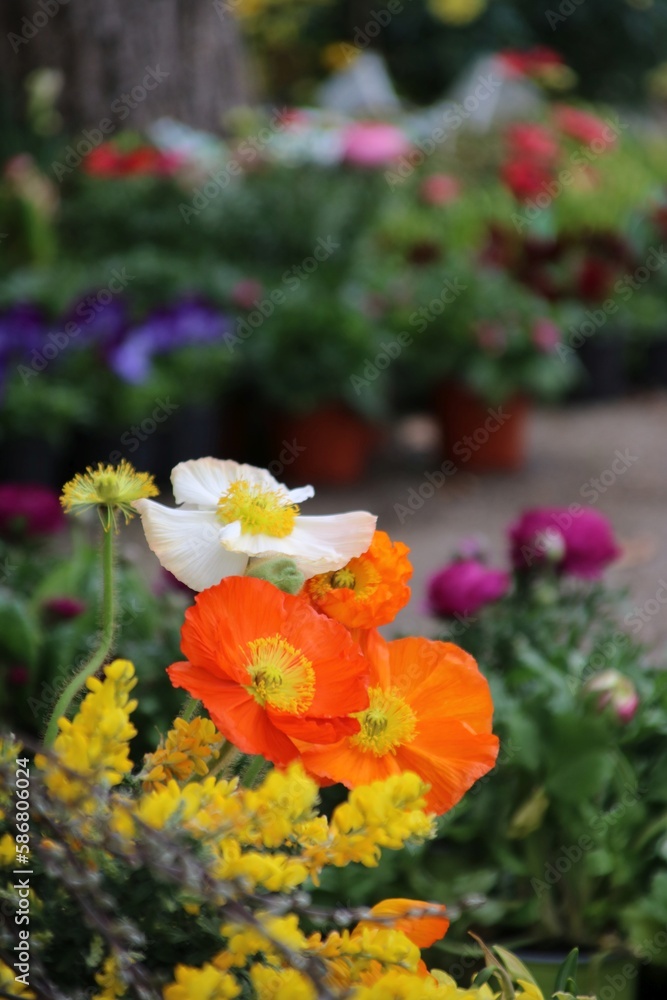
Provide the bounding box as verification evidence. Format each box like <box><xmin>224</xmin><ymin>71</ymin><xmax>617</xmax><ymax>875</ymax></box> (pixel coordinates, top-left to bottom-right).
<box><xmin>305</xmin><ymin>531</ymin><xmax>412</xmax><ymax>628</ymax></box>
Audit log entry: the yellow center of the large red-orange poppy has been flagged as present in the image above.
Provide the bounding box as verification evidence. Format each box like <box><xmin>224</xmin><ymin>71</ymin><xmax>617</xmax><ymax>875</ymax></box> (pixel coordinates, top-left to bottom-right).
<box><xmin>246</xmin><ymin>635</ymin><xmax>315</xmax><ymax>714</ymax></box>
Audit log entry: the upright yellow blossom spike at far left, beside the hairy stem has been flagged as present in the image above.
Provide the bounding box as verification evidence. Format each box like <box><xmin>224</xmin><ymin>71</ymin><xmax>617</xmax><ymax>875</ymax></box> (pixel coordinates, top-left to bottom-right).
<box><xmin>35</xmin><ymin>660</ymin><xmax>137</xmax><ymax>812</ymax></box>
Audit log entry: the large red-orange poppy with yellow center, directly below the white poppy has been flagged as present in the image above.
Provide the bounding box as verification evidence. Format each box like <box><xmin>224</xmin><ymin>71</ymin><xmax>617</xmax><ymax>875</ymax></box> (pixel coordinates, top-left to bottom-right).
<box><xmin>167</xmin><ymin>576</ymin><xmax>368</xmax><ymax>765</ymax></box>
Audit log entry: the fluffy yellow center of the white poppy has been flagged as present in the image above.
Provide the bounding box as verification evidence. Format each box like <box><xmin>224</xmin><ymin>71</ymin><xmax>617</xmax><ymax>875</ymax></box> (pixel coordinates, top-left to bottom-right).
<box><xmin>217</xmin><ymin>479</ymin><xmax>299</xmax><ymax>538</ymax></box>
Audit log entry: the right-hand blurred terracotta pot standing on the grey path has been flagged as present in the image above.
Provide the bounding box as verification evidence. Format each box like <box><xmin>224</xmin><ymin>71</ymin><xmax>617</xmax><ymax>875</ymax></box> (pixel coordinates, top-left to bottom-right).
<box><xmin>436</xmin><ymin>382</ymin><xmax>530</xmax><ymax>472</ymax></box>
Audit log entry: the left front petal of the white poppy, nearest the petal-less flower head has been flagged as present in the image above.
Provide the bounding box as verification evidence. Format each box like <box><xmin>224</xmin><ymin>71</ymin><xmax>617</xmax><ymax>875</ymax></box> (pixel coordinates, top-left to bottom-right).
<box><xmin>133</xmin><ymin>500</ymin><xmax>248</xmax><ymax>590</ymax></box>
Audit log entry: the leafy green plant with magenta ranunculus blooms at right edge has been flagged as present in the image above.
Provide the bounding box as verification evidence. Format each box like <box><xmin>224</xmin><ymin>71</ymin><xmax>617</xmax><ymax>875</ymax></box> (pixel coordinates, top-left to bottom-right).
<box><xmin>425</xmin><ymin>508</ymin><xmax>667</xmax><ymax>997</ymax></box>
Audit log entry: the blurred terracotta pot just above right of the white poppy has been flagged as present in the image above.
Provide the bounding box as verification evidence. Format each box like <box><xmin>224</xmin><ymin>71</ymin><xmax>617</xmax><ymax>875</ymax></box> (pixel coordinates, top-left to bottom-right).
<box><xmin>268</xmin><ymin>403</ymin><xmax>377</xmax><ymax>485</ymax></box>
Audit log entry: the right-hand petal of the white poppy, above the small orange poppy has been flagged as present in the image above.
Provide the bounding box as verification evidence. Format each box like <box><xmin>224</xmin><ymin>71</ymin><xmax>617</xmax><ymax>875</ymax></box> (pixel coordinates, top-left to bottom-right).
<box><xmin>221</xmin><ymin>510</ymin><xmax>377</xmax><ymax>578</ymax></box>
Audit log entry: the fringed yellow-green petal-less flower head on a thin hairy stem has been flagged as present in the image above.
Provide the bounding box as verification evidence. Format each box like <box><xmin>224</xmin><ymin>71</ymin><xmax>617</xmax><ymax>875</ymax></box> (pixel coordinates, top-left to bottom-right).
<box><xmin>60</xmin><ymin>459</ymin><xmax>159</xmax><ymax>531</ymax></box>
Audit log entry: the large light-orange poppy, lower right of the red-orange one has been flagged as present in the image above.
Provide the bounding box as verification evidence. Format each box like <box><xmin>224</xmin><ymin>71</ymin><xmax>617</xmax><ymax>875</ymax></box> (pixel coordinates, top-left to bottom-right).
<box><xmin>301</xmin><ymin>629</ymin><xmax>498</xmax><ymax>813</ymax></box>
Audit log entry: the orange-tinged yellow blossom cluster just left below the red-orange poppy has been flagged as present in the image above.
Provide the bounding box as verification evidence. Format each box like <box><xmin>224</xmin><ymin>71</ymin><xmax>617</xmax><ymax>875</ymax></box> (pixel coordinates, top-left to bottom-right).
<box><xmin>140</xmin><ymin>716</ymin><xmax>225</xmax><ymax>791</ymax></box>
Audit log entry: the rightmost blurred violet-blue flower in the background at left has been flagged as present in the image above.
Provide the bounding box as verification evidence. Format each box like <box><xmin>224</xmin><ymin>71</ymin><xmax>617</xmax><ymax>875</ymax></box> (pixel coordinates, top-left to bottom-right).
<box><xmin>109</xmin><ymin>299</ymin><xmax>228</xmax><ymax>385</ymax></box>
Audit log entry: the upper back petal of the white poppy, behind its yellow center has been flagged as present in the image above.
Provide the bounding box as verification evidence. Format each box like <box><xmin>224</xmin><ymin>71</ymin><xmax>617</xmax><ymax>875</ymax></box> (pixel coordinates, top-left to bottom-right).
<box><xmin>171</xmin><ymin>458</ymin><xmax>294</xmax><ymax>510</ymax></box>
